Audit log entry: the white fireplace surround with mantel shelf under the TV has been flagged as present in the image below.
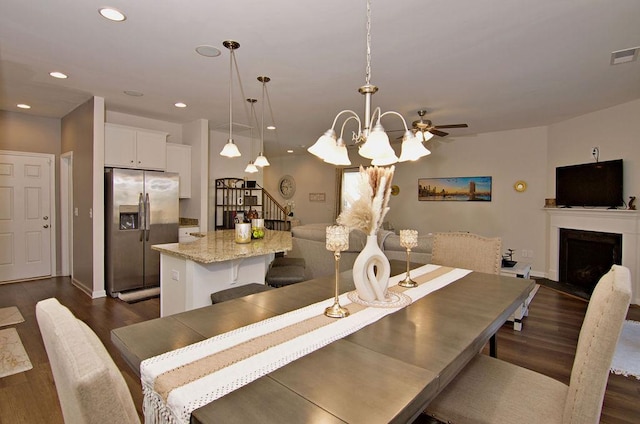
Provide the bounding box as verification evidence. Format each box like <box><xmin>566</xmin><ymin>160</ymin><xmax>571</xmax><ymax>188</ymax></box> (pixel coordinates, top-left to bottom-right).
<box><xmin>545</xmin><ymin>208</ymin><xmax>640</xmax><ymax>305</ymax></box>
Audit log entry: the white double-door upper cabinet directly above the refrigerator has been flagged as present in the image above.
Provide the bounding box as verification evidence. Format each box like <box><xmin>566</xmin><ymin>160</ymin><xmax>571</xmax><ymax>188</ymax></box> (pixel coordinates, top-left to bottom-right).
<box><xmin>104</xmin><ymin>123</ymin><xmax>168</xmax><ymax>171</ymax></box>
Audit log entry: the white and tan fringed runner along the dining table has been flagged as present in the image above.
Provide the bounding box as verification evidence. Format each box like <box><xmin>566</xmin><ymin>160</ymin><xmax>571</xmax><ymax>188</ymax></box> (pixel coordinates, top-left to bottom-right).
<box><xmin>140</xmin><ymin>265</ymin><xmax>471</xmax><ymax>423</ymax></box>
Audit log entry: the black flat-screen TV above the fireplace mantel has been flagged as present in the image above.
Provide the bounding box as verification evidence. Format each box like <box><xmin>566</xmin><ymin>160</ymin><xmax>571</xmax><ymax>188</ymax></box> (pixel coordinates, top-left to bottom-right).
<box><xmin>556</xmin><ymin>159</ymin><xmax>624</xmax><ymax>208</ymax></box>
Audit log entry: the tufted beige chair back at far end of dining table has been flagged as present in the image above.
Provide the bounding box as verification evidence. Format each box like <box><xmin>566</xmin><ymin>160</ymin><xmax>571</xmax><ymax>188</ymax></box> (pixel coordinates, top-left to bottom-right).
<box><xmin>431</xmin><ymin>232</ymin><xmax>502</xmax><ymax>274</ymax></box>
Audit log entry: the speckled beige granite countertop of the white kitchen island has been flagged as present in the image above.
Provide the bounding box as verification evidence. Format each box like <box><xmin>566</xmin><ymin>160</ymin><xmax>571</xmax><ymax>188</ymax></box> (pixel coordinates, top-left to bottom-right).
<box><xmin>151</xmin><ymin>230</ymin><xmax>292</xmax><ymax>264</ymax></box>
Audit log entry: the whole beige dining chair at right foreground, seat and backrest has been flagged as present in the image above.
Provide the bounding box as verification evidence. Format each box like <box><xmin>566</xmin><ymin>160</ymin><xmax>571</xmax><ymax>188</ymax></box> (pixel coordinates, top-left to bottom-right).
<box><xmin>426</xmin><ymin>265</ymin><xmax>631</xmax><ymax>424</ymax></box>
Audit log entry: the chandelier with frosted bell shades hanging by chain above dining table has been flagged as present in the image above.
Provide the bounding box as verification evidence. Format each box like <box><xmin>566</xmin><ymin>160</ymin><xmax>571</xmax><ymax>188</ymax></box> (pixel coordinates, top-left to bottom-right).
<box><xmin>307</xmin><ymin>0</ymin><xmax>431</xmax><ymax>166</ymax></box>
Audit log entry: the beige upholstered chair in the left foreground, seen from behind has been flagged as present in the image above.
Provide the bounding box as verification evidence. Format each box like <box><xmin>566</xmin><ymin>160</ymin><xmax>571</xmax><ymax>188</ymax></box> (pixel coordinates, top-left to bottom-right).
<box><xmin>36</xmin><ymin>298</ymin><xmax>140</xmax><ymax>424</ymax></box>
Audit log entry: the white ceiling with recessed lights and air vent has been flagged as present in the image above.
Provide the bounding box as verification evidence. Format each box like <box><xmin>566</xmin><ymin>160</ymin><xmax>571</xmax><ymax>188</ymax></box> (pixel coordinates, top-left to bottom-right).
<box><xmin>0</xmin><ymin>0</ymin><xmax>640</xmax><ymax>154</ymax></box>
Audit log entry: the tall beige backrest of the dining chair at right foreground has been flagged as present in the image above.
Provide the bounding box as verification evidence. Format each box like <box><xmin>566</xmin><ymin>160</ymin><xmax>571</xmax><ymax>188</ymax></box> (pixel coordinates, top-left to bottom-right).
<box><xmin>563</xmin><ymin>265</ymin><xmax>631</xmax><ymax>424</ymax></box>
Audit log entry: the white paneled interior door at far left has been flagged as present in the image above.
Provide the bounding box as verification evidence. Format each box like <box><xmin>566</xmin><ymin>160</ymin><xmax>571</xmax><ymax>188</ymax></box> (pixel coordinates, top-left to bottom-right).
<box><xmin>0</xmin><ymin>154</ymin><xmax>53</xmax><ymax>281</ymax></box>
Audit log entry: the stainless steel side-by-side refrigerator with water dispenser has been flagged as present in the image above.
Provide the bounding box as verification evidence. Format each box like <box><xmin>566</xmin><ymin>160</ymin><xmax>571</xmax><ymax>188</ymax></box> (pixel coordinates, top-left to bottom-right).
<box><xmin>105</xmin><ymin>168</ymin><xmax>179</xmax><ymax>297</ymax></box>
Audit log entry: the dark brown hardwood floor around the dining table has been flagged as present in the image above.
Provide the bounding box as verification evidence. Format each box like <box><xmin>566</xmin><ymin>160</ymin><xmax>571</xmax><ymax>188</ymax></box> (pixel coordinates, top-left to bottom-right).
<box><xmin>0</xmin><ymin>278</ymin><xmax>640</xmax><ymax>424</ymax></box>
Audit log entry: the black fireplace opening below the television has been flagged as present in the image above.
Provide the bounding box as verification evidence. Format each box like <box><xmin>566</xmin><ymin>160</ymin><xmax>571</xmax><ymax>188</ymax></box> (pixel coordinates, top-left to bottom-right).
<box><xmin>559</xmin><ymin>228</ymin><xmax>622</xmax><ymax>294</ymax></box>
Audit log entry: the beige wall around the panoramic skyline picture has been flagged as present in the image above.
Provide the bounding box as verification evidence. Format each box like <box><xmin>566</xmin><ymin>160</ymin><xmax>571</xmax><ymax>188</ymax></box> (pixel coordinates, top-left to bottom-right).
<box><xmin>387</xmin><ymin>127</ymin><xmax>546</xmax><ymax>272</ymax></box>
